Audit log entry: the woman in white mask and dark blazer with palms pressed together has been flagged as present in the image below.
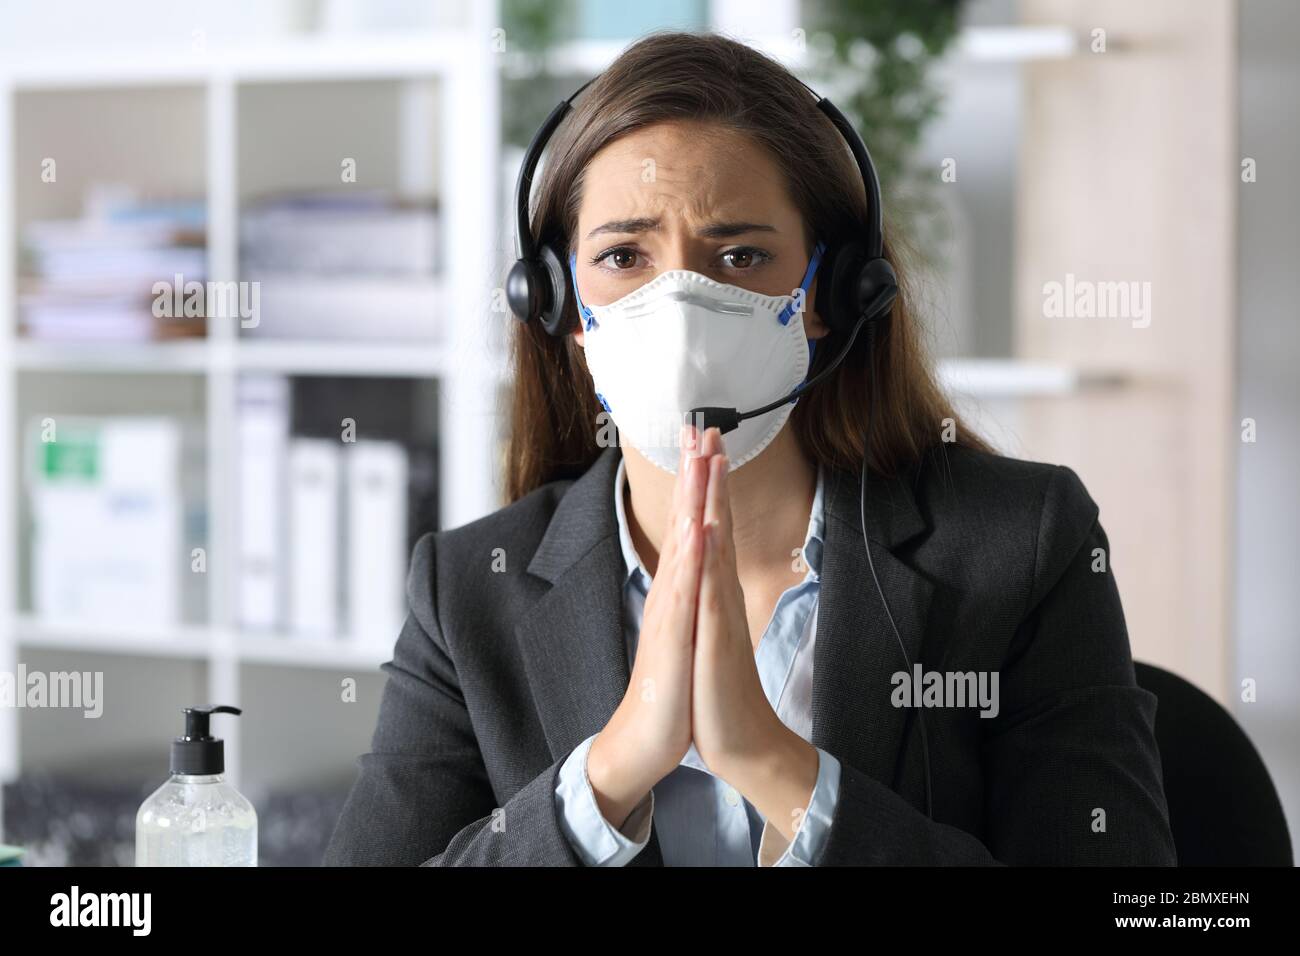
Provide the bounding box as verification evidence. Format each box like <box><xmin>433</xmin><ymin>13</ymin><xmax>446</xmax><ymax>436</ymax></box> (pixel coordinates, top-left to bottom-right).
<box><xmin>326</xmin><ymin>34</ymin><xmax>1175</xmax><ymax>866</ymax></box>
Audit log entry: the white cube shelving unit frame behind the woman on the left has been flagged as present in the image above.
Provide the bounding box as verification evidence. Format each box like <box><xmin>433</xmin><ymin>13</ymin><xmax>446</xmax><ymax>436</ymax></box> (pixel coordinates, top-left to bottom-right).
<box><xmin>0</xmin><ymin>13</ymin><xmax>502</xmax><ymax>801</ymax></box>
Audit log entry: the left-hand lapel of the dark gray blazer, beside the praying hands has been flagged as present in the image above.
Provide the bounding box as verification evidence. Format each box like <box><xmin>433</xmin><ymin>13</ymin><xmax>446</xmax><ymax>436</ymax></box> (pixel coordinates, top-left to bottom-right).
<box><xmin>515</xmin><ymin>447</ymin><xmax>663</xmax><ymax>866</ymax></box>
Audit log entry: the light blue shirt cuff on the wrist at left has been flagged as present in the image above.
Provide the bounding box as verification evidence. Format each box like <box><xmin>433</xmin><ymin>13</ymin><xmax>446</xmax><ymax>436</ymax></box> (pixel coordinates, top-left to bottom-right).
<box><xmin>555</xmin><ymin>734</ymin><xmax>654</xmax><ymax>866</ymax></box>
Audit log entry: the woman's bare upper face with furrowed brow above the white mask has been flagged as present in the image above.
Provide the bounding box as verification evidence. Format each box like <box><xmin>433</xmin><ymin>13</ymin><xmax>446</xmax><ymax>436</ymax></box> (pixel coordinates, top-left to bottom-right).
<box><xmin>573</xmin><ymin>121</ymin><xmax>827</xmax><ymax>345</ymax></box>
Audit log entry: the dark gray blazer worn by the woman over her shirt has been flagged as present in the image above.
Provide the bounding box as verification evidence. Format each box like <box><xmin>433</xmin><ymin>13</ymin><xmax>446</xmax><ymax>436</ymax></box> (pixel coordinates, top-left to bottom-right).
<box><xmin>325</xmin><ymin>445</ymin><xmax>1175</xmax><ymax>866</ymax></box>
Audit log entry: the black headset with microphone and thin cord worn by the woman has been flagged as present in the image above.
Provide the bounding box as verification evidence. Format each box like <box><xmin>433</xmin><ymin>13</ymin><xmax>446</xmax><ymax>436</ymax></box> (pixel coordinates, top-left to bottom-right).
<box><xmin>506</xmin><ymin>70</ymin><xmax>933</xmax><ymax>818</ymax></box>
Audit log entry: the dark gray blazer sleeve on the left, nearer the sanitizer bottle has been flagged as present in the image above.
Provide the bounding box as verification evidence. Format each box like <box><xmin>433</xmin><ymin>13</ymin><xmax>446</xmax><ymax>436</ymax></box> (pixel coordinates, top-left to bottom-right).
<box><xmin>324</xmin><ymin>533</ymin><xmax>581</xmax><ymax>866</ymax></box>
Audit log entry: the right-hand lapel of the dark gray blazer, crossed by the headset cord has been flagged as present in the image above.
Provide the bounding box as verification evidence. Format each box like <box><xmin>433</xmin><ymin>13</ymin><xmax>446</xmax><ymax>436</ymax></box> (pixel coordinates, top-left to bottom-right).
<box><xmin>811</xmin><ymin>460</ymin><xmax>933</xmax><ymax>808</ymax></box>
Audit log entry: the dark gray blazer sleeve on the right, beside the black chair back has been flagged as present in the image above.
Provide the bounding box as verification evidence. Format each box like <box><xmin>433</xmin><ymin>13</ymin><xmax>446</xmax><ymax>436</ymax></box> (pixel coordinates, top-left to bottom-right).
<box><xmin>819</xmin><ymin>466</ymin><xmax>1177</xmax><ymax>866</ymax></box>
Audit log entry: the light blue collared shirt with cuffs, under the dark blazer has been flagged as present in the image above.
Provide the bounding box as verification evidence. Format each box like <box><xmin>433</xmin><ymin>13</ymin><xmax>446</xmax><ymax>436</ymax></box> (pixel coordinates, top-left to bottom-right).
<box><xmin>555</xmin><ymin>460</ymin><xmax>840</xmax><ymax>866</ymax></box>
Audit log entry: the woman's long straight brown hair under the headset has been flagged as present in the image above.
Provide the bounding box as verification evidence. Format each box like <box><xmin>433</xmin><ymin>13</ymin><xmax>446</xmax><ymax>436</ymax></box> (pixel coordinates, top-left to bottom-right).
<box><xmin>506</xmin><ymin>33</ymin><xmax>991</xmax><ymax>501</ymax></box>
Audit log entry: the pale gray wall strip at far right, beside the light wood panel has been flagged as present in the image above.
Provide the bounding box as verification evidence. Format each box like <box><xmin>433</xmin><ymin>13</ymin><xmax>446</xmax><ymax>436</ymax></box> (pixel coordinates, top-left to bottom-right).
<box><xmin>1235</xmin><ymin>0</ymin><xmax>1300</xmax><ymax>843</ymax></box>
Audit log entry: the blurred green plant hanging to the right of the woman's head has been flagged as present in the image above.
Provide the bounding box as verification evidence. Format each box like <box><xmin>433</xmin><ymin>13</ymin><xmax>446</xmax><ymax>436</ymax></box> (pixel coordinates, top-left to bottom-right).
<box><xmin>803</xmin><ymin>0</ymin><xmax>965</xmax><ymax>263</ymax></box>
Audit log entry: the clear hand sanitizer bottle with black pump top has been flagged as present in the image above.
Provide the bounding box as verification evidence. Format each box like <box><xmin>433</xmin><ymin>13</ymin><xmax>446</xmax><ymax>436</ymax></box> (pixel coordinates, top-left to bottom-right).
<box><xmin>135</xmin><ymin>706</ymin><xmax>257</xmax><ymax>866</ymax></box>
